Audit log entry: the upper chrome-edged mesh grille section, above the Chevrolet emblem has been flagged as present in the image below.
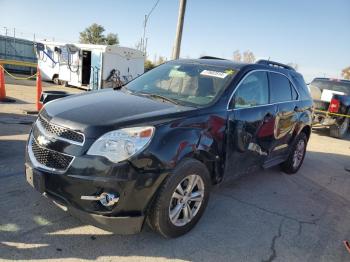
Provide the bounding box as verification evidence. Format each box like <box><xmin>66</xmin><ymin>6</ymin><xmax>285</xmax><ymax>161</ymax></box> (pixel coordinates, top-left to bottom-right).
<box><xmin>38</xmin><ymin>116</ymin><xmax>84</xmax><ymax>143</ymax></box>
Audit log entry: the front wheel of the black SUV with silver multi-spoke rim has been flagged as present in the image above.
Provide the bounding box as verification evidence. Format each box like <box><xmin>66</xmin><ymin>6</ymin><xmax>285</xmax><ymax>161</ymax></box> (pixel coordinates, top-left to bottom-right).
<box><xmin>147</xmin><ymin>159</ymin><xmax>211</xmax><ymax>238</ymax></box>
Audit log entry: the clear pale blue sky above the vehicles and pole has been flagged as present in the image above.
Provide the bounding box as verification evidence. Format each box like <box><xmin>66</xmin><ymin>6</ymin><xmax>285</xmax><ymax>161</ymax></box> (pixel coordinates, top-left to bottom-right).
<box><xmin>0</xmin><ymin>0</ymin><xmax>350</xmax><ymax>81</ymax></box>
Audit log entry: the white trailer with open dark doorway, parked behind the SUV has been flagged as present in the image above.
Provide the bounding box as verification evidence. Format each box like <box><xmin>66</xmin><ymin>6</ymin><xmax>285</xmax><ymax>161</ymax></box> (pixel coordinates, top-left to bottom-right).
<box><xmin>36</xmin><ymin>41</ymin><xmax>145</xmax><ymax>89</ymax></box>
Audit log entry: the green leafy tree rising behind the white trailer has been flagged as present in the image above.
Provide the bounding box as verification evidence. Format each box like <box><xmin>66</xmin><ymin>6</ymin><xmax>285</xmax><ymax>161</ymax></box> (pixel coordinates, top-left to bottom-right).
<box><xmin>79</xmin><ymin>23</ymin><xmax>119</xmax><ymax>45</ymax></box>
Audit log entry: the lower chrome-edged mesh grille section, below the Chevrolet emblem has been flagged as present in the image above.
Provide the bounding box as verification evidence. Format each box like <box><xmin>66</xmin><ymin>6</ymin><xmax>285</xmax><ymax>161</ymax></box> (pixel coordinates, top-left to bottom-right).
<box><xmin>30</xmin><ymin>137</ymin><xmax>74</xmax><ymax>172</ymax></box>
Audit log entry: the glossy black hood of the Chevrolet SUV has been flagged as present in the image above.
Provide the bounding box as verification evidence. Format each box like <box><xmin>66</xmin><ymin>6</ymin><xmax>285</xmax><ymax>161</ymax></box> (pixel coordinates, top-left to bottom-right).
<box><xmin>41</xmin><ymin>89</ymin><xmax>195</xmax><ymax>136</ymax></box>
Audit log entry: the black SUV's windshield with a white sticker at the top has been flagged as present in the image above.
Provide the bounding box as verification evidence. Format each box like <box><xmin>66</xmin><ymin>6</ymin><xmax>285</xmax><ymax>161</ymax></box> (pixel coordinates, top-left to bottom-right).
<box><xmin>126</xmin><ymin>63</ymin><xmax>236</xmax><ymax>106</ymax></box>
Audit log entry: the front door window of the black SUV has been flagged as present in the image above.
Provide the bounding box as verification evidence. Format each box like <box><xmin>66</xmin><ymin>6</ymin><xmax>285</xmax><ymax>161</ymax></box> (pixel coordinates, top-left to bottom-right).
<box><xmin>231</xmin><ymin>71</ymin><xmax>269</xmax><ymax>108</ymax></box>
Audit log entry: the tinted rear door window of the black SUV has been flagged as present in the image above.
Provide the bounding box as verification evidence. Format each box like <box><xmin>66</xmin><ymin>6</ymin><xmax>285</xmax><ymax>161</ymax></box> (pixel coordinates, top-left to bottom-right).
<box><xmin>269</xmin><ymin>73</ymin><xmax>292</xmax><ymax>103</ymax></box>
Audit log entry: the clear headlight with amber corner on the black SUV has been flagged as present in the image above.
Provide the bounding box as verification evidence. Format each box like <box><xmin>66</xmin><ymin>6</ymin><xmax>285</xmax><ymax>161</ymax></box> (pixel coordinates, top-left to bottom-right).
<box><xmin>87</xmin><ymin>126</ymin><xmax>154</xmax><ymax>163</ymax></box>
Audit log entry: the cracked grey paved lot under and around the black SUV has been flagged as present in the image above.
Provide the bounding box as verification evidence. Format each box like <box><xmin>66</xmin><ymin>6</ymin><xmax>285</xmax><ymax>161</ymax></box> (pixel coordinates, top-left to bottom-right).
<box><xmin>0</xmin><ymin>83</ymin><xmax>350</xmax><ymax>261</ymax></box>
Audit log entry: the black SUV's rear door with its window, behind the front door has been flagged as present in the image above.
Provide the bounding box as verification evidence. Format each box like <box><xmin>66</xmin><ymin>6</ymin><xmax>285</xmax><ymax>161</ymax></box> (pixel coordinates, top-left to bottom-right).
<box><xmin>269</xmin><ymin>72</ymin><xmax>299</xmax><ymax>159</ymax></box>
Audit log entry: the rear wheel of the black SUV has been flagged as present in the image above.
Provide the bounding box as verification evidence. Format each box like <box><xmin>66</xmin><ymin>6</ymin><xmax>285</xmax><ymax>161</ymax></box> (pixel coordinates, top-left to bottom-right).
<box><xmin>281</xmin><ymin>132</ymin><xmax>308</xmax><ymax>175</ymax></box>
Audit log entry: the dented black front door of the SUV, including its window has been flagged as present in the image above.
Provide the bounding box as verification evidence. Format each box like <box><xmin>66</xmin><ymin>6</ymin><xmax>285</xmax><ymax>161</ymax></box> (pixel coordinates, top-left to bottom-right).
<box><xmin>225</xmin><ymin>70</ymin><xmax>277</xmax><ymax>178</ymax></box>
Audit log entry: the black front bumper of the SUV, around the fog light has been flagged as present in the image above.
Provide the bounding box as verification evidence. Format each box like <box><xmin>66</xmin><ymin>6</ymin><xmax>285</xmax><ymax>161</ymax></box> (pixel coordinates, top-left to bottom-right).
<box><xmin>25</xmin><ymin>152</ymin><xmax>166</xmax><ymax>234</ymax></box>
